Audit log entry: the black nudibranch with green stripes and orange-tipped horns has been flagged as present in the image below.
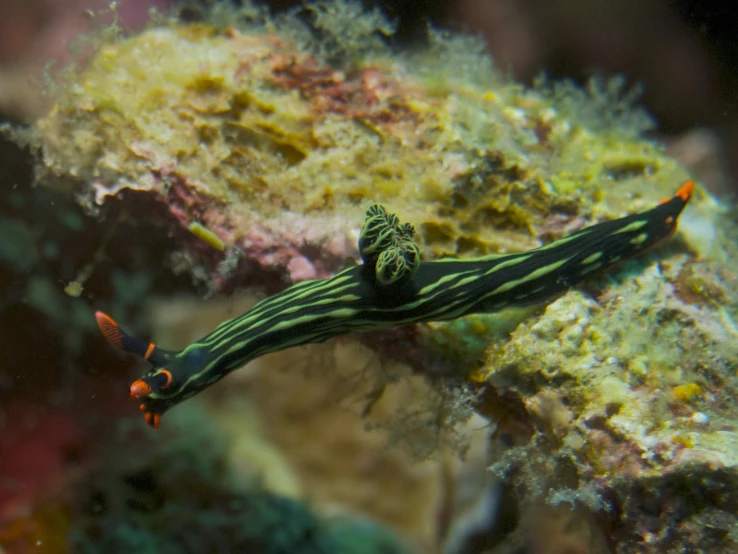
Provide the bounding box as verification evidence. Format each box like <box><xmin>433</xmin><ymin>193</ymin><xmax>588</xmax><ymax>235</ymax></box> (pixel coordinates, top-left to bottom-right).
<box><xmin>95</xmin><ymin>181</ymin><xmax>694</xmax><ymax>428</ymax></box>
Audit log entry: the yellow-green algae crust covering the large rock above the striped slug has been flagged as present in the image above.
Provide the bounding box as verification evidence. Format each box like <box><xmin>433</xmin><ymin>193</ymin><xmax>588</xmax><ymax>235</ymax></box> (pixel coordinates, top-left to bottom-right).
<box><xmin>31</xmin><ymin>2</ymin><xmax>686</xmax><ymax>256</ymax></box>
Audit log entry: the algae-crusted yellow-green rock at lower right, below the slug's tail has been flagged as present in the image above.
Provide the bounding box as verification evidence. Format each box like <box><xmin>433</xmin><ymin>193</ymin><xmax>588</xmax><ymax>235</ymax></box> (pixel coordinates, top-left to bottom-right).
<box><xmin>477</xmin><ymin>245</ymin><xmax>738</xmax><ymax>552</ymax></box>
